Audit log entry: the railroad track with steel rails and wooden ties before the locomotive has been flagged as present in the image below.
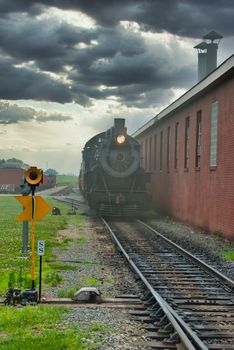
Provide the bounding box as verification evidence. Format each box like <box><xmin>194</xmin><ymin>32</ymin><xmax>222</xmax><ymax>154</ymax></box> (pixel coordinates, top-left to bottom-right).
<box><xmin>102</xmin><ymin>219</ymin><xmax>234</xmax><ymax>350</ymax></box>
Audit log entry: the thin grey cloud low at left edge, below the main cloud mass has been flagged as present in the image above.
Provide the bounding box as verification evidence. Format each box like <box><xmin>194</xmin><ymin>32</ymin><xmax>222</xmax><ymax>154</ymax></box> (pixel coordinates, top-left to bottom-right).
<box><xmin>0</xmin><ymin>102</ymin><xmax>72</xmax><ymax>124</ymax></box>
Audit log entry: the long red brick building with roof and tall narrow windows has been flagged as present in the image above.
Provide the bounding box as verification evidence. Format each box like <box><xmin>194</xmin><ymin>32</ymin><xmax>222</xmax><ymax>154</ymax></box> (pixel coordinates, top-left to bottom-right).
<box><xmin>133</xmin><ymin>55</ymin><xmax>234</xmax><ymax>239</ymax></box>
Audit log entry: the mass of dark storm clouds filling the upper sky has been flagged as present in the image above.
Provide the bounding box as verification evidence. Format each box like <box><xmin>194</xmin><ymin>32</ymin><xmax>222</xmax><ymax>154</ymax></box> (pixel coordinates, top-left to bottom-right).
<box><xmin>0</xmin><ymin>0</ymin><xmax>231</xmax><ymax>112</ymax></box>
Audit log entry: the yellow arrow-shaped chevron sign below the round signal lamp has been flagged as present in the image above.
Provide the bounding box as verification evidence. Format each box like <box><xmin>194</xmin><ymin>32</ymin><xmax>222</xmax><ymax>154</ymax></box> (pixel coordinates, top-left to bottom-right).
<box><xmin>15</xmin><ymin>196</ymin><xmax>52</xmax><ymax>221</ymax></box>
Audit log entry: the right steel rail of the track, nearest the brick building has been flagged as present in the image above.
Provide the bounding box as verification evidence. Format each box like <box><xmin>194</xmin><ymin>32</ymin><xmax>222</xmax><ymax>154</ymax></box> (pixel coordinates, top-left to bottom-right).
<box><xmin>137</xmin><ymin>220</ymin><xmax>234</xmax><ymax>289</ymax></box>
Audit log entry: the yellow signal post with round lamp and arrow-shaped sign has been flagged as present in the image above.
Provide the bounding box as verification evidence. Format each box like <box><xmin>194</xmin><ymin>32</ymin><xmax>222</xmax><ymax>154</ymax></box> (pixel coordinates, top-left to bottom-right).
<box><xmin>16</xmin><ymin>167</ymin><xmax>51</xmax><ymax>296</ymax></box>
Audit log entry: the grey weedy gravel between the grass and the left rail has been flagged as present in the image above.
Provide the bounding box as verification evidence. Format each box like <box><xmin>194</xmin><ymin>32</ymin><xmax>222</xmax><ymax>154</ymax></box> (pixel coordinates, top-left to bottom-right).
<box><xmin>43</xmin><ymin>198</ymin><xmax>148</xmax><ymax>350</ymax></box>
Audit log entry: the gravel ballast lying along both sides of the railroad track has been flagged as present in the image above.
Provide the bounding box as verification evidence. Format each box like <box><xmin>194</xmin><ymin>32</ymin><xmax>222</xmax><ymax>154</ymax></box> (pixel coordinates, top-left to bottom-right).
<box><xmin>44</xmin><ymin>190</ymin><xmax>234</xmax><ymax>350</ymax></box>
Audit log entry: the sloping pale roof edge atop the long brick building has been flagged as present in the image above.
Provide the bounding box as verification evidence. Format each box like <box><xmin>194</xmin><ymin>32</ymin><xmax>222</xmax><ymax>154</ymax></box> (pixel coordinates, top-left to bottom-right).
<box><xmin>132</xmin><ymin>55</ymin><xmax>234</xmax><ymax>137</ymax></box>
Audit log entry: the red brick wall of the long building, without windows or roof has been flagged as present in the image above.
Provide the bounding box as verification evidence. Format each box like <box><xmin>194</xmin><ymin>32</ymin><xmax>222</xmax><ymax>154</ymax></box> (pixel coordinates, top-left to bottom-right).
<box><xmin>137</xmin><ymin>79</ymin><xmax>234</xmax><ymax>239</ymax></box>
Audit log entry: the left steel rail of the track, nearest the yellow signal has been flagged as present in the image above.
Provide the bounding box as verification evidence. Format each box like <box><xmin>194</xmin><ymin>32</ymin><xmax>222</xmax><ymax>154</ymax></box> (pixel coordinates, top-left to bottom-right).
<box><xmin>101</xmin><ymin>218</ymin><xmax>208</xmax><ymax>350</ymax></box>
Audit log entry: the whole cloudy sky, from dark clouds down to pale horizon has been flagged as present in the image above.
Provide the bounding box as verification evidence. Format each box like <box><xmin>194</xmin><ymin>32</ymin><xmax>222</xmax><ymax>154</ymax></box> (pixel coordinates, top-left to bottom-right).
<box><xmin>0</xmin><ymin>0</ymin><xmax>234</xmax><ymax>173</ymax></box>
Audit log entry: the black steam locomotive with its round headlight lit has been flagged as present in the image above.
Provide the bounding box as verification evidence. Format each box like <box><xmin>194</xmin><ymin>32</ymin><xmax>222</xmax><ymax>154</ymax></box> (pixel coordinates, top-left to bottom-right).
<box><xmin>79</xmin><ymin>118</ymin><xmax>150</xmax><ymax>217</ymax></box>
